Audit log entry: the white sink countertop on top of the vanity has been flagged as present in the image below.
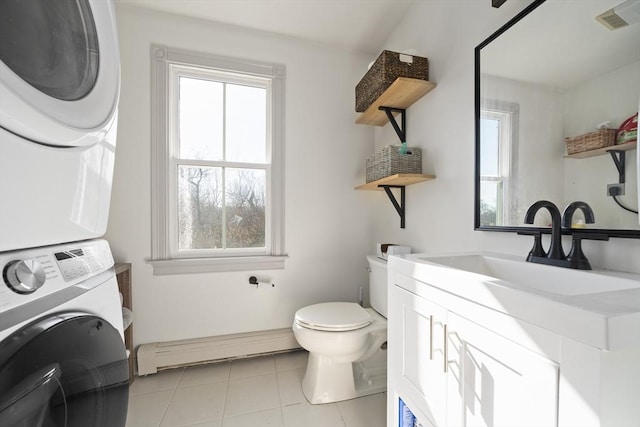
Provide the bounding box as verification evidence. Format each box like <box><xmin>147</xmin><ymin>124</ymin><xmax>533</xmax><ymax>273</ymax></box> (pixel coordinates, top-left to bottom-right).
<box><xmin>388</xmin><ymin>253</ymin><xmax>640</xmax><ymax>350</ymax></box>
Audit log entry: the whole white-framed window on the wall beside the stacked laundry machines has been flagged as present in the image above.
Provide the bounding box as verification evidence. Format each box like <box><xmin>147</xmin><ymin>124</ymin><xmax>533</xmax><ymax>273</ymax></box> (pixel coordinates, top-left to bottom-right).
<box><xmin>151</xmin><ymin>46</ymin><xmax>286</xmax><ymax>274</ymax></box>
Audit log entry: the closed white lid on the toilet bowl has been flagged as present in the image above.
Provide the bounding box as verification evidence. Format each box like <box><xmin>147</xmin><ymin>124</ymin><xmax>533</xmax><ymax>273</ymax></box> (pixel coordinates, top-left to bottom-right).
<box><xmin>296</xmin><ymin>302</ymin><xmax>372</xmax><ymax>332</ymax></box>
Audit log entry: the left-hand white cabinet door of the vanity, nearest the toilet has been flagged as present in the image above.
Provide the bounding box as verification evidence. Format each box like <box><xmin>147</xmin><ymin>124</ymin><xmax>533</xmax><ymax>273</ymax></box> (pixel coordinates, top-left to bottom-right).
<box><xmin>390</xmin><ymin>287</ymin><xmax>447</xmax><ymax>426</ymax></box>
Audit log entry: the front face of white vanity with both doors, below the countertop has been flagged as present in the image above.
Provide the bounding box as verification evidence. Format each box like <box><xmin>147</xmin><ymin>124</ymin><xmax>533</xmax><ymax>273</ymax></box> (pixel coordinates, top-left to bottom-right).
<box><xmin>388</xmin><ymin>276</ymin><xmax>558</xmax><ymax>427</ymax></box>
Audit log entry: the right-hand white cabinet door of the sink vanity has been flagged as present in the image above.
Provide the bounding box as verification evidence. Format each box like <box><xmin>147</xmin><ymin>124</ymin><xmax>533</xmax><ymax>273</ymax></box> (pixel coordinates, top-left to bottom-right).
<box><xmin>446</xmin><ymin>312</ymin><xmax>559</xmax><ymax>427</ymax></box>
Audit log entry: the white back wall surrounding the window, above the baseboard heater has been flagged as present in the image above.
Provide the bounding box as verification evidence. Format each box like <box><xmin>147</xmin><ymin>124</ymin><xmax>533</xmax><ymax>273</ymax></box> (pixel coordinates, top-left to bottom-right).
<box><xmin>106</xmin><ymin>7</ymin><xmax>373</xmax><ymax>345</ymax></box>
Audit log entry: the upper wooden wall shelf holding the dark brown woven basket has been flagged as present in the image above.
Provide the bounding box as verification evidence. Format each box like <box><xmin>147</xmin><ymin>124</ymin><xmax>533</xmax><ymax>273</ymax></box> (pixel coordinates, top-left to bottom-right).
<box><xmin>356</xmin><ymin>77</ymin><xmax>436</xmax><ymax>126</ymax></box>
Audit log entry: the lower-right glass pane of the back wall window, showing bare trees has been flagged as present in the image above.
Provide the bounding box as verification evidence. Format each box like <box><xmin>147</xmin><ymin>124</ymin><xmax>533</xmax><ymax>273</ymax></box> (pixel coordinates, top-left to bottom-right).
<box><xmin>226</xmin><ymin>168</ymin><xmax>266</xmax><ymax>248</ymax></box>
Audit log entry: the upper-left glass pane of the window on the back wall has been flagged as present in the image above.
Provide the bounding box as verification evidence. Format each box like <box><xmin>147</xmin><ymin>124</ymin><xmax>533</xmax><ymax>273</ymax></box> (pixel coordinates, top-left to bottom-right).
<box><xmin>179</xmin><ymin>77</ymin><xmax>223</xmax><ymax>160</ymax></box>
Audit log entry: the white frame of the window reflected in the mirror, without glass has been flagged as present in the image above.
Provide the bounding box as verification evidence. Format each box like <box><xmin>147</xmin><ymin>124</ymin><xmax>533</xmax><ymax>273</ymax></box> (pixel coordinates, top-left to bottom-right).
<box><xmin>480</xmin><ymin>100</ymin><xmax>520</xmax><ymax>226</ymax></box>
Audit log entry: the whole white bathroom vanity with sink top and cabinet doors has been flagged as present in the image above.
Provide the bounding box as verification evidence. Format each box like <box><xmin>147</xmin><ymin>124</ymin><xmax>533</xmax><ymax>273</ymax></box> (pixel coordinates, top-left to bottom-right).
<box><xmin>387</xmin><ymin>259</ymin><xmax>640</xmax><ymax>427</ymax></box>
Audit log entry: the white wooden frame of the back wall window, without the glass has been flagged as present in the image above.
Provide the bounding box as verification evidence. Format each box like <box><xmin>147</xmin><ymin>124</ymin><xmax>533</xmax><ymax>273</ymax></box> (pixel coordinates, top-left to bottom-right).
<box><xmin>149</xmin><ymin>45</ymin><xmax>287</xmax><ymax>274</ymax></box>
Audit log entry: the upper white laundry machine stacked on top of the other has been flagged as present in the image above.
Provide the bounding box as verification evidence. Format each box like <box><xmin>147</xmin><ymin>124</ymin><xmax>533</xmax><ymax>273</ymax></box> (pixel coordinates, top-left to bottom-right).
<box><xmin>0</xmin><ymin>0</ymin><xmax>120</xmax><ymax>252</ymax></box>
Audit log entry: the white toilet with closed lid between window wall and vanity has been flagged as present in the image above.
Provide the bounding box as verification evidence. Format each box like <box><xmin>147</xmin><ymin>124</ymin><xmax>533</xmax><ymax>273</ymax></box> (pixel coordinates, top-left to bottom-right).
<box><xmin>293</xmin><ymin>255</ymin><xmax>387</xmax><ymax>404</ymax></box>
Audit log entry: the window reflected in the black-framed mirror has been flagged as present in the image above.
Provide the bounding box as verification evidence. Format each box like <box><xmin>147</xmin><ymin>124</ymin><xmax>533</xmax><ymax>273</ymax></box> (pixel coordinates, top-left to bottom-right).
<box><xmin>480</xmin><ymin>102</ymin><xmax>518</xmax><ymax>225</ymax></box>
